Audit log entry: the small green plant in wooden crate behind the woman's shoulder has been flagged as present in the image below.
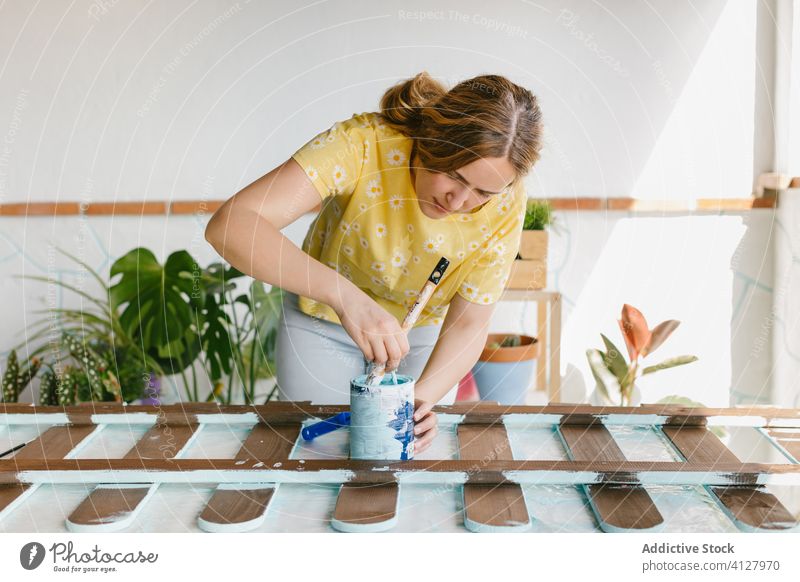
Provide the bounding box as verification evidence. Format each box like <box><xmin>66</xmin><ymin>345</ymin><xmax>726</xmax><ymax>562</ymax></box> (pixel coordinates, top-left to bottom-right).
<box><xmin>506</xmin><ymin>199</ymin><xmax>553</xmax><ymax>289</ymax></box>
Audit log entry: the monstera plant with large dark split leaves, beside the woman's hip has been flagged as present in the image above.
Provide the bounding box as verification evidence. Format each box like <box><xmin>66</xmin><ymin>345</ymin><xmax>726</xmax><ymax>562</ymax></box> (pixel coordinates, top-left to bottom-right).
<box><xmin>106</xmin><ymin>248</ymin><xmax>282</xmax><ymax>404</ymax></box>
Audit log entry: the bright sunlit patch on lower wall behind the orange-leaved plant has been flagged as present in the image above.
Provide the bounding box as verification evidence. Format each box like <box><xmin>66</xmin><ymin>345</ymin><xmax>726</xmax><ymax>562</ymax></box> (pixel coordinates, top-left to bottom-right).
<box><xmin>563</xmin><ymin>216</ymin><xmax>745</xmax><ymax>406</ymax></box>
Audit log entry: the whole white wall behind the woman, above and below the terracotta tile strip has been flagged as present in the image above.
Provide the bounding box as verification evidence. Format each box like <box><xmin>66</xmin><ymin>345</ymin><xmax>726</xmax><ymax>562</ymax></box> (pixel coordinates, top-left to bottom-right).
<box><xmin>0</xmin><ymin>0</ymin><xmax>780</xmax><ymax>404</ymax></box>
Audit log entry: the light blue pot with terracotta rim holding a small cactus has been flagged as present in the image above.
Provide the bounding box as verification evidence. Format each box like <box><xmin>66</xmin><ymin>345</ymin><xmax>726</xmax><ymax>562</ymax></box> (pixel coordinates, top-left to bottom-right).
<box><xmin>472</xmin><ymin>334</ymin><xmax>539</xmax><ymax>404</ymax></box>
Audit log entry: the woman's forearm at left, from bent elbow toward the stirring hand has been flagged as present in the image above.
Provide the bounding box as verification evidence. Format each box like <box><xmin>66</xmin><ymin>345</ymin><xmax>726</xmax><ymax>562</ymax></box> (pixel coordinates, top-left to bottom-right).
<box><xmin>206</xmin><ymin>209</ymin><xmax>358</xmax><ymax>312</ymax></box>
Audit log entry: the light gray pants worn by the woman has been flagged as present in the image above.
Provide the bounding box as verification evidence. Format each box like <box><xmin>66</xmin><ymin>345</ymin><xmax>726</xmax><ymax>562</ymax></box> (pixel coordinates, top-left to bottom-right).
<box><xmin>276</xmin><ymin>292</ymin><xmax>458</xmax><ymax>404</ymax></box>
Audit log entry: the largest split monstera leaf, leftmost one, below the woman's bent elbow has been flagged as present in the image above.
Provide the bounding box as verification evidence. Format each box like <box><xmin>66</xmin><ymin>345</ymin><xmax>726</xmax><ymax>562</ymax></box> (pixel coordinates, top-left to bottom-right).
<box><xmin>109</xmin><ymin>248</ymin><xmax>202</xmax><ymax>371</ymax></box>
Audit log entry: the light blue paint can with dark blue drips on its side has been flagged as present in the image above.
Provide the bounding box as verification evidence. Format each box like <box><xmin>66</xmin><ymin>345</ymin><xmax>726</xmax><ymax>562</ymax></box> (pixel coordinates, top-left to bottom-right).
<box><xmin>350</xmin><ymin>374</ymin><xmax>414</xmax><ymax>461</ymax></box>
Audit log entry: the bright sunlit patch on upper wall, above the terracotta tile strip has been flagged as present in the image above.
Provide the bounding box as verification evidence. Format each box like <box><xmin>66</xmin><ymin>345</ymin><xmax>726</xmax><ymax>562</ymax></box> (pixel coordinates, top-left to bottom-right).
<box><xmin>631</xmin><ymin>0</ymin><xmax>758</xmax><ymax>199</ymax></box>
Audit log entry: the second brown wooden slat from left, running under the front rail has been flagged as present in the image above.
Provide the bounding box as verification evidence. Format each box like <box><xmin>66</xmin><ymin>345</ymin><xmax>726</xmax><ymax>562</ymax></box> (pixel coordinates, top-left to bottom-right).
<box><xmin>66</xmin><ymin>424</ymin><xmax>198</xmax><ymax>532</ymax></box>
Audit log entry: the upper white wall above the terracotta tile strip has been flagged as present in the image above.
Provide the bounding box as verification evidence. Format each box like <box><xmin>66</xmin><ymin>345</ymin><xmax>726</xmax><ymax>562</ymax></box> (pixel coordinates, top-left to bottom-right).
<box><xmin>0</xmin><ymin>0</ymin><xmax>756</xmax><ymax>201</ymax></box>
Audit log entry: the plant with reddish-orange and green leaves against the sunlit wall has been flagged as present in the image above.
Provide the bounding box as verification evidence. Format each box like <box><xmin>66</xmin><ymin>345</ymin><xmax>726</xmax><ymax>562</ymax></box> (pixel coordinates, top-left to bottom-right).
<box><xmin>586</xmin><ymin>303</ymin><xmax>697</xmax><ymax>406</ymax></box>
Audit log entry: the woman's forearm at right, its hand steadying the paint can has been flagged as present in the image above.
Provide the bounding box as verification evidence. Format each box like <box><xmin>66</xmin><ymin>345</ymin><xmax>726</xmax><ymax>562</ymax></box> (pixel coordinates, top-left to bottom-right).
<box><xmin>415</xmin><ymin>318</ymin><xmax>489</xmax><ymax>403</ymax></box>
